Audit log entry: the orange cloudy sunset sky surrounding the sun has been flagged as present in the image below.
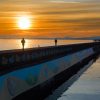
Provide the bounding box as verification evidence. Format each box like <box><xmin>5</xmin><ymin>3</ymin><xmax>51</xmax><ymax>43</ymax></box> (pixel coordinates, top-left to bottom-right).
<box><xmin>0</xmin><ymin>0</ymin><xmax>100</xmax><ymax>38</ymax></box>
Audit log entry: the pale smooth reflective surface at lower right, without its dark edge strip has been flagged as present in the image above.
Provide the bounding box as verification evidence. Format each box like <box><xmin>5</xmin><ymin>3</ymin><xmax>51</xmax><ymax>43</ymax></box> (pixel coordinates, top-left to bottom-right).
<box><xmin>57</xmin><ymin>58</ymin><xmax>100</xmax><ymax>100</ymax></box>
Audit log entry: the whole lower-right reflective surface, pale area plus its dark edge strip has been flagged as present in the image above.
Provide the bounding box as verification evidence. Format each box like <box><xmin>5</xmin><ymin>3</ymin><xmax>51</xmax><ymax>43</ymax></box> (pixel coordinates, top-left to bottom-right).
<box><xmin>46</xmin><ymin>58</ymin><xmax>100</xmax><ymax>100</ymax></box>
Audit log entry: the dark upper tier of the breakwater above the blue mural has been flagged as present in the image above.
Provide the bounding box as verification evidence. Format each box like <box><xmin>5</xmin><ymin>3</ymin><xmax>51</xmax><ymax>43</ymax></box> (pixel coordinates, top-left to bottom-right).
<box><xmin>0</xmin><ymin>42</ymin><xmax>100</xmax><ymax>73</ymax></box>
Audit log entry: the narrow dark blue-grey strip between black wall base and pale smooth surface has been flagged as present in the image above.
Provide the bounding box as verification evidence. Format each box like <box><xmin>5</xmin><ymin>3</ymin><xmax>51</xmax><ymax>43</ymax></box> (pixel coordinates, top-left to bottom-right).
<box><xmin>45</xmin><ymin>60</ymin><xmax>93</xmax><ymax>100</ymax></box>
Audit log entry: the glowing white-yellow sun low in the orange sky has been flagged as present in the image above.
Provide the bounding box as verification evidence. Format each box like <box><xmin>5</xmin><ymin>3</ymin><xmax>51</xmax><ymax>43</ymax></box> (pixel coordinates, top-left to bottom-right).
<box><xmin>18</xmin><ymin>16</ymin><xmax>31</xmax><ymax>29</ymax></box>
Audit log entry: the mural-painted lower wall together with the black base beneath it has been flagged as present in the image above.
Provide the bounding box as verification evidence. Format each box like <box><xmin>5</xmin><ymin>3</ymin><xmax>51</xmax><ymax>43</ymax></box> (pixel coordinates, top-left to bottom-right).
<box><xmin>0</xmin><ymin>41</ymin><xmax>100</xmax><ymax>100</ymax></box>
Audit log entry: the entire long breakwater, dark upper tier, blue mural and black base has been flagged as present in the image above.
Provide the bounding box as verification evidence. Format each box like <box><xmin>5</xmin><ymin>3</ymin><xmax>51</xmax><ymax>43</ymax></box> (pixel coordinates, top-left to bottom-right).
<box><xmin>0</xmin><ymin>42</ymin><xmax>100</xmax><ymax>100</ymax></box>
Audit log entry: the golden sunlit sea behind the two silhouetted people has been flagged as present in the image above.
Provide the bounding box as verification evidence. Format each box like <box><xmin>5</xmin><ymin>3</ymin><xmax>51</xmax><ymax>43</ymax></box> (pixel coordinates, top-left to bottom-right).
<box><xmin>0</xmin><ymin>39</ymin><xmax>92</xmax><ymax>51</ymax></box>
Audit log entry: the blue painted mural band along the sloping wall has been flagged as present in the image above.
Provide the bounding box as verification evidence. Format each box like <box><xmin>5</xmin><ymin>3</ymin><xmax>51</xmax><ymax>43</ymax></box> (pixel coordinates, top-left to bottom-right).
<box><xmin>0</xmin><ymin>48</ymin><xmax>94</xmax><ymax>100</ymax></box>
